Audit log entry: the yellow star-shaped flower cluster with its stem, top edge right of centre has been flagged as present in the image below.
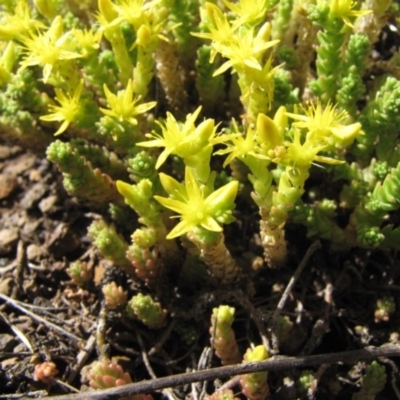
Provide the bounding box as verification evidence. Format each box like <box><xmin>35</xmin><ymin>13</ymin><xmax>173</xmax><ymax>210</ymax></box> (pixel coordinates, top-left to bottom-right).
<box><xmin>193</xmin><ymin>1</ymin><xmax>279</xmax><ymax>120</ymax></box>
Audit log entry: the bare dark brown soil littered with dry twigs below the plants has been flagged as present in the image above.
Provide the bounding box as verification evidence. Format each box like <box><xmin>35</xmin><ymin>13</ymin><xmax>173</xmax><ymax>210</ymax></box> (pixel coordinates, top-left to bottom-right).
<box><xmin>0</xmin><ymin>144</ymin><xmax>400</xmax><ymax>400</ymax></box>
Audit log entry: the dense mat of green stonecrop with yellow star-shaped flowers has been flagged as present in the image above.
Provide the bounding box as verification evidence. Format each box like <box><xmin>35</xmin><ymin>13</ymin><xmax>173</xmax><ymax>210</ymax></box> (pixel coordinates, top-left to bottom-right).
<box><xmin>0</xmin><ymin>0</ymin><xmax>400</xmax><ymax>399</ymax></box>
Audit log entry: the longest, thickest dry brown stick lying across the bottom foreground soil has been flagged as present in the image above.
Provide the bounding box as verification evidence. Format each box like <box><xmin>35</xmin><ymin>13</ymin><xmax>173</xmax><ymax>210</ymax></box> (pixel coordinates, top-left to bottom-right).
<box><xmin>48</xmin><ymin>344</ymin><xmax>400</xmax><ymax>400</ymax></box>
